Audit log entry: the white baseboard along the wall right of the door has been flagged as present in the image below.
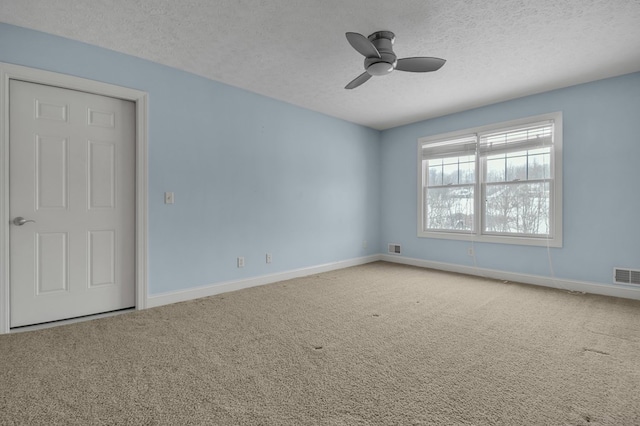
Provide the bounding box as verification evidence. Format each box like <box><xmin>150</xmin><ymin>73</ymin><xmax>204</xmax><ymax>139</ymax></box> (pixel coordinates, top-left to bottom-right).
<box><xmin>147</xmin><ymin>254</ymin><xmax>381</xmax><ymax>308</ymax></box>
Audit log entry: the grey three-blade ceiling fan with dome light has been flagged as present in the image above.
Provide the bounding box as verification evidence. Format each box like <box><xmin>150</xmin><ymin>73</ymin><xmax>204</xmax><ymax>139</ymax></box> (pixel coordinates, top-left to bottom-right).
<box><xmin>344</xmin><ymin>31</ymin><xmax>446</xmax><ymax>89</ymax></box>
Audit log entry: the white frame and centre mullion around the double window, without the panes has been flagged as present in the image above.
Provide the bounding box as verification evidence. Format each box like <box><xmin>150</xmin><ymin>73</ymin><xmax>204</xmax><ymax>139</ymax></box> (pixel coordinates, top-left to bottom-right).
<box><xmin>417</xmin><ymin>112</ymin><xmax>563</xmax><ymax>247</ymax></box>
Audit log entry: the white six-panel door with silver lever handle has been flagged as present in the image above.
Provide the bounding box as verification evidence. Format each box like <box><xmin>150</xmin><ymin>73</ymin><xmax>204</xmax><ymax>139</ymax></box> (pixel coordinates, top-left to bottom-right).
<box><xmin>9</xmin><ymin>80</ymin><xmax>135</xmax><ymax>327</ymax></box>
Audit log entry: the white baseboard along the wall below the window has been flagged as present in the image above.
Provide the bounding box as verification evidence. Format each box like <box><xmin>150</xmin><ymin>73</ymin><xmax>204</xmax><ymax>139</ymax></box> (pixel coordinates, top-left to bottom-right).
<box><xmin>381</xmin><ymin>255</ymin><xmax>640</xmax><ymax>300</ymax></box>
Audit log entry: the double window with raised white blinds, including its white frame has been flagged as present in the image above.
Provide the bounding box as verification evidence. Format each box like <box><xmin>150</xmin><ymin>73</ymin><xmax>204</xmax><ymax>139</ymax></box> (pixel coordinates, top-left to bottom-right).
<box><xmin>418</xmin><ymin>113</ymin><xmax>562</xmax><ymax>247</ymax></box>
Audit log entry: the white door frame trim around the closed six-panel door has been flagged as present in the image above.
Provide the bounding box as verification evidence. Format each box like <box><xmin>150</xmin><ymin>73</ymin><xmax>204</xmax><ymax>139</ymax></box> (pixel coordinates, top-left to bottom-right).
<box><xmin>0</xmin><ymin>62</ymin><xmax>148</xmax><ymax>334</ymax></box>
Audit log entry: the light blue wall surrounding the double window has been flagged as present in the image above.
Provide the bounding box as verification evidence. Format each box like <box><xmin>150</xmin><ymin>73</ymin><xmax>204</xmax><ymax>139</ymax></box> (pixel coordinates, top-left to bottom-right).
<box><xmin>380</xmin><ymin>73</ymin><xmax>640</xmax><ymax>284</ymax></box>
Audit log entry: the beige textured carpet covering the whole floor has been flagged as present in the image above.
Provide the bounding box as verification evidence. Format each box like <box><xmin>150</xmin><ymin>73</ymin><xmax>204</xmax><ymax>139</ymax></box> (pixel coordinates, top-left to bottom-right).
<box><xmin>0</xmin><ymin>262</ymin><xmax>640</xmax><ymax>426</ymax></box>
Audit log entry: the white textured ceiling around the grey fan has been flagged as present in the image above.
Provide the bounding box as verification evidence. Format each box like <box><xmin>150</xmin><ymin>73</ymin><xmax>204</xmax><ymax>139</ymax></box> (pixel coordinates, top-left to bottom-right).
<box><xmin>0</xmin><ymin>0</ymin><xmax>640</xmax><ymax>129</ymax></box>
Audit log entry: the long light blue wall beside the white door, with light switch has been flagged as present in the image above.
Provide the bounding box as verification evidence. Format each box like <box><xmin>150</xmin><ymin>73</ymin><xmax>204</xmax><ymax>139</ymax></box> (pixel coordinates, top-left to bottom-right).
<box><xmin>0</xmin><ymin>24</ymin><xmax>380</xmax><ymax>294</ymax></box>
